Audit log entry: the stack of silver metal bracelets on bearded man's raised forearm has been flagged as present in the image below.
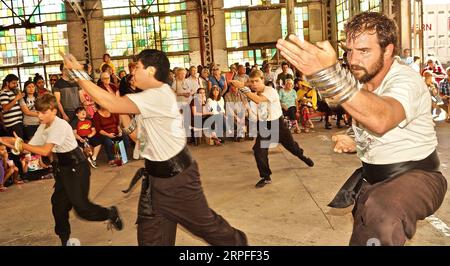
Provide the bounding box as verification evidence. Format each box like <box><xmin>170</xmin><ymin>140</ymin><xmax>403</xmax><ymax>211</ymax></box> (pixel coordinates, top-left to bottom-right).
<box><xmin>306</xmin><ymin>63</ymin><xmax>362</xmax><ymax>106</ymax></box>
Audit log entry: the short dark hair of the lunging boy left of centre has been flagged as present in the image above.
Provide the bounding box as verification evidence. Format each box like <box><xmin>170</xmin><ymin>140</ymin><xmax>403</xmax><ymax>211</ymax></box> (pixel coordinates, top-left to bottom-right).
<box><xmin>135</xmin><ymin>49</ymin><xmax>170</xmax><ymax>83</ymax></box>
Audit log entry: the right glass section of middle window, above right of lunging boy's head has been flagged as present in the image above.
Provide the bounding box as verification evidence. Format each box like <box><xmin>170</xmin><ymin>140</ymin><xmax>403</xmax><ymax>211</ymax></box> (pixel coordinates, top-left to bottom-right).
<box><xmin>160</xmin><ymin>15</ymin><xmax>189</xmax><ymax>52</ymax></box>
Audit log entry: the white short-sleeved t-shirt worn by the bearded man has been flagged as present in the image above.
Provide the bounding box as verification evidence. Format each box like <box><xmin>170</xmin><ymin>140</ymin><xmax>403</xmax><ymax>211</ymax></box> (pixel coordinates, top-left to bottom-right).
<box><xmin>353</xmin><ymin>61</ymin><xmax>437</xmax><ymax>164</ymax></box>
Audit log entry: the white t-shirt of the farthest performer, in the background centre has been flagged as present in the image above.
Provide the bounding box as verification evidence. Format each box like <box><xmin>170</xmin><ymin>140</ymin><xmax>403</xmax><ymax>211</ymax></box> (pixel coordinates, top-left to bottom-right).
<box><xmin>257</xmin><ymin>86</ymin><xmax>283</xmax><ymax>121</ymax></box>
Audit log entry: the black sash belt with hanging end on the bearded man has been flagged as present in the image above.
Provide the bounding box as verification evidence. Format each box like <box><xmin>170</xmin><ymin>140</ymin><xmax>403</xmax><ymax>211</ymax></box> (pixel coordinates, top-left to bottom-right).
<box><xmin>328</xmin><ymin>150</ymin><xmax>440</xmax><ymax>208</ymax></box>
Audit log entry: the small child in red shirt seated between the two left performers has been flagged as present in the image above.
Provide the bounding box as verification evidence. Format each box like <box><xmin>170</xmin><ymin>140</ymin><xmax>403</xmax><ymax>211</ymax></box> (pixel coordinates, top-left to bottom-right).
<box><xmin>71</xmin><ymin>107</ymin><xmax>101</xmax><ymax>168</ymax></box>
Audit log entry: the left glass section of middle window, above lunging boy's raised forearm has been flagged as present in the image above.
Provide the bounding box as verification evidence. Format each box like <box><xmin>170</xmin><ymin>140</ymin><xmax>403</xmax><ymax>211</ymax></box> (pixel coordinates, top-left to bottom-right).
<box><xmin>105</xmin><ymin>19</ymin><xmax>133</xmax><ymax>56</ymax></box>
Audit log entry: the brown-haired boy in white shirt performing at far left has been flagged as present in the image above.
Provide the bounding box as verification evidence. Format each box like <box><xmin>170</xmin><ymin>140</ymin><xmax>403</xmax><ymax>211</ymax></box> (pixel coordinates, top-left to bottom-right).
<box><xmin>0</xmin><ymin>94</ymin><xmax>123</xmax><ymax>246</ymax></box>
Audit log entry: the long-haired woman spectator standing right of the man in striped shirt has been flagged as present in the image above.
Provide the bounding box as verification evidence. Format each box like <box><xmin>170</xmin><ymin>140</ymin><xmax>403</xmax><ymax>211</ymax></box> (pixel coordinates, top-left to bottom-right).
<box><xmin>23</xmin><ymin>80</ymin><xmax>39</xmax><ymax>140</ymax></box>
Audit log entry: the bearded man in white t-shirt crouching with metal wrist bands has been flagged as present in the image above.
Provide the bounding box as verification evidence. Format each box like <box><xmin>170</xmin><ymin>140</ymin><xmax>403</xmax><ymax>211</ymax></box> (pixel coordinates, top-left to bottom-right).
<box><xmin>277</xmin><ymin>12</ymin><xmax>447</xmax><ymax>245</ymax></box>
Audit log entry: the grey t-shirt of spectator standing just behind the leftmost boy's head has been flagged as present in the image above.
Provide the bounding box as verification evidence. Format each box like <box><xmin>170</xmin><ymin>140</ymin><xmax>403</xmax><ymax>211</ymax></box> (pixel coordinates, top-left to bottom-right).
<box><xmin>53</xmin><ymin>79</ymin><xmax>82</xmax><ymax>111</ymax></box>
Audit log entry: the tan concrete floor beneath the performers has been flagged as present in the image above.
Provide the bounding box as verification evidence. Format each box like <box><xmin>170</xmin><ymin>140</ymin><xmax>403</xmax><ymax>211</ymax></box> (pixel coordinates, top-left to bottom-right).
<box><xmin>0</xmin><ymin>119</ymin><xmax>450</xmax><ymax>246</ymax></box>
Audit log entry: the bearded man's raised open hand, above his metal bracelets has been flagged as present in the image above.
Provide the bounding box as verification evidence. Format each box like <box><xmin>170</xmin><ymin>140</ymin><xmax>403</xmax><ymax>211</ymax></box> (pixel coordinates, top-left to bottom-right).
<box><xmin>277</xmin><ymin>34</ymin><xmax>337</xmax><ymax>76</ymax></box>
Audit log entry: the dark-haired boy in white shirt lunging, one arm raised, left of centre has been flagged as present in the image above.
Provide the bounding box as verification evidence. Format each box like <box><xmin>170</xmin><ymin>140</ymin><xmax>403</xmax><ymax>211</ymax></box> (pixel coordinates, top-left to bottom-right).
<box><xmin>60</xmin><ymin>49</ymin><xmax>247</xmax><ymax>246</ymax></box>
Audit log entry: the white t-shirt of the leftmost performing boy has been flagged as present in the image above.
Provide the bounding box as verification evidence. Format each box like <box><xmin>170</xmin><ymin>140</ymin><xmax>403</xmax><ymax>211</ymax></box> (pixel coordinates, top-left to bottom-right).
<box><xmin>29</xmin><ymin>117</ymin><xmax>78</xmax><ymax>153</ymax></box>
